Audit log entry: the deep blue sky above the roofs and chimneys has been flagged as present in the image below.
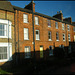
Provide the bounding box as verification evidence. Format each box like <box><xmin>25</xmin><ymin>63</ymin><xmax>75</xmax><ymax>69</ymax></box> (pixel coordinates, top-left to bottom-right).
<box><xmin>10</xmin><ymin>1</ymin><xmax>75</xmax><ymax>22</ymax></box>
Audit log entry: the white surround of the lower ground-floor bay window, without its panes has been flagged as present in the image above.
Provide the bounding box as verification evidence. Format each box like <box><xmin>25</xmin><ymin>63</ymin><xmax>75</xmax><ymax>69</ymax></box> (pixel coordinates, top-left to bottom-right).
<box><xmin>0</xmin><ymin>43</ymin><xmax>12</xmax><ymax>62</ymax></box>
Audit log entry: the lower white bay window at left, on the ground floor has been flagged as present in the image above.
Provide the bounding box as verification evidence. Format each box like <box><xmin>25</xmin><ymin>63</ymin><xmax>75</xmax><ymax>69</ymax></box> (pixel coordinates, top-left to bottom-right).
<box><xmin>0</xmin><ymin>43</ymin><xmax>12</xmax><ymax>62</ymax></box>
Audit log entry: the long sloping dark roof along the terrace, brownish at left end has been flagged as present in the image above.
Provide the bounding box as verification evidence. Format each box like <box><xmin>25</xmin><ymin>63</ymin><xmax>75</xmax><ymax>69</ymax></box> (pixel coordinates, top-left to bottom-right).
<box><xmin>0</xmin><ymin>1</ymin><xmax>73</xmax><ymax>25</ymax></box>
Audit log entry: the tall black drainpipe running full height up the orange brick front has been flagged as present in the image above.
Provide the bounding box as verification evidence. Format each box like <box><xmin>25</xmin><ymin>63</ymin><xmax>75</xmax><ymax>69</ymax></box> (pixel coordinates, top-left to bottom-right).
<box><xmin>32</xmin><ymin>0</ymin><xmax>36</xmax><ymax>70</ymax></box>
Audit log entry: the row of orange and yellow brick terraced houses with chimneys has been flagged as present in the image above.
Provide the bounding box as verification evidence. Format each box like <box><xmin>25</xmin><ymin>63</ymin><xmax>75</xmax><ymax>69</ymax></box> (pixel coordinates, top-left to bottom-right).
<box><xmin>0</xmin><ymin>1</ymin><xmax>75</xmax><ymax>65</ymax></box>
